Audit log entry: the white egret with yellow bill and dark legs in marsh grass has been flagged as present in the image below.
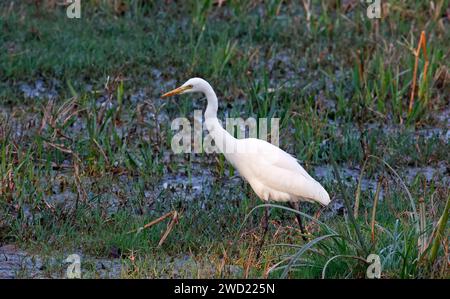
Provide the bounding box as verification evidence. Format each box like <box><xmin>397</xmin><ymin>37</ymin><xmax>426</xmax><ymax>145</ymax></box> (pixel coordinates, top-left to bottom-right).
<box><xmin>162</xmin><ymin>78</ymin><xmax>330</xmax><ymax>255</ymax></box>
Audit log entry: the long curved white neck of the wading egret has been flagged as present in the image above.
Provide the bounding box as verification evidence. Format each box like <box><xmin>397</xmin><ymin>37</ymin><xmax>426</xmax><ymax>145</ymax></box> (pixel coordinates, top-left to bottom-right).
<box><xmin>203</xmin><ymin>84</ymin><xmax>235</xmax><ymax>154</ymax></box>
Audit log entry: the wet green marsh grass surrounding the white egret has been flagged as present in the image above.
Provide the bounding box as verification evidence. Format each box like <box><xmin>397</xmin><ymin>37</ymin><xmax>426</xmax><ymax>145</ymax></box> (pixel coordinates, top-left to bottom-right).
<box><xmin>0</xmin><ymin>0</ymin><xmax>450</xmax><ymax>278</ymax></box>
